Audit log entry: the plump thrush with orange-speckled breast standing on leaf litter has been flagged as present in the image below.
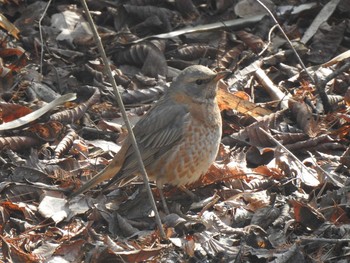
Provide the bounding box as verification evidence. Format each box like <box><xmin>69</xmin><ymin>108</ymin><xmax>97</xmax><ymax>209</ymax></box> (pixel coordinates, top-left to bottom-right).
<box><xmin>69</xmin><ymin>65</ymin><xmax>229</xmax><ymax>205</ymax></box>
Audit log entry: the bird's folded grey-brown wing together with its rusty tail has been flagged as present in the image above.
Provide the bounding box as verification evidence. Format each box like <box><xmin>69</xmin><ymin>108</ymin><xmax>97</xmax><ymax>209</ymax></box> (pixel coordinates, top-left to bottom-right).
<box><xmin>70</xmin><ymin>99</ymin><xmax>190</xmax><ymax>198</ymax></box>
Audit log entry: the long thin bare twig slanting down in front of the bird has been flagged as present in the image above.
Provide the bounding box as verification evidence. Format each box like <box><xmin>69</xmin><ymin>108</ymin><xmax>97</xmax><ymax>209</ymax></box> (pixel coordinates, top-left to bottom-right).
<box><xmin>80</xmin><ymin>0</ymin><xmax>166</xmax><ymax>239</ymax></box>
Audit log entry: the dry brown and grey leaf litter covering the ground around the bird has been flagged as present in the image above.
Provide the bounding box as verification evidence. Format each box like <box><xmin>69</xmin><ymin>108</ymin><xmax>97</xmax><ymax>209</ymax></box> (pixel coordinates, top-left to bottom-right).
<box><xmin>0</xmin><ymin>0</ymin><xmax>350</xmax><ymax>262</ymax></box>
